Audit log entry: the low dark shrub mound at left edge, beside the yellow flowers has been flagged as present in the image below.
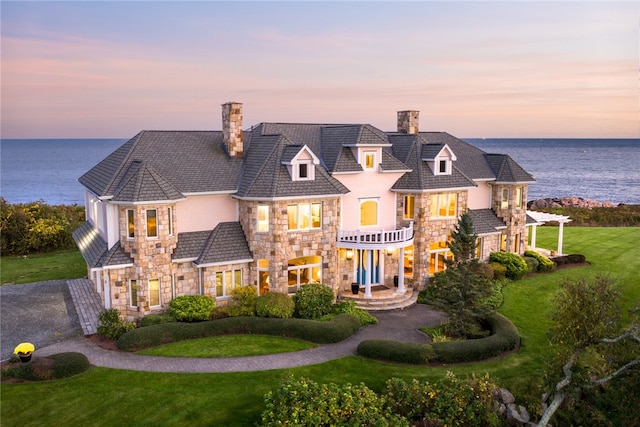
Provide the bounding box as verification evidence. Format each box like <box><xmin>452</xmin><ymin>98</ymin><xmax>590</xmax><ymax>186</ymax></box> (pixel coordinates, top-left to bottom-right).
<box><xmin>2</xmin><ymin>352</ymin><xmax>91</xmax><ymax>381</ymax></box>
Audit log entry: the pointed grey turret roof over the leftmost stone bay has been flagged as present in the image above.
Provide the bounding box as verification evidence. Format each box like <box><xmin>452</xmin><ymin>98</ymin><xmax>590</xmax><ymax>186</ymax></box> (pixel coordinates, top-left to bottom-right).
<box><xmin>111</xmin><ymin>161</ymin><xmax>185</xmax><ymax>203</ymax></box>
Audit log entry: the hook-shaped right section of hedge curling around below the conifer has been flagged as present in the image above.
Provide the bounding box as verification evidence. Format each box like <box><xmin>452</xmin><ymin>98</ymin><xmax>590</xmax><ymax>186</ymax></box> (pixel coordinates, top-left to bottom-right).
<box><xmin>432</xmin><ymin>313</ymin><xmax>520</xmax><ymax>363</ymax></box>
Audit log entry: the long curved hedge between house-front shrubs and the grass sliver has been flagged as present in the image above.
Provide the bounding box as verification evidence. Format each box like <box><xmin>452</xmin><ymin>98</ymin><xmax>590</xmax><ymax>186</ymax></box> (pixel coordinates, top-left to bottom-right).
<box><xmin>117</xmin><ymin>314</ymin><xmax>360</xmax><ymax>351</ymax></box>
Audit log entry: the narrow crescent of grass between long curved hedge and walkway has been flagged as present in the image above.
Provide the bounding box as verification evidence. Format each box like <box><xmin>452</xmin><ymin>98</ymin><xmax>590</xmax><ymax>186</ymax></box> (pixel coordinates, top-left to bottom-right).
<box><xmin>137</xmin><ymin>335</ymin><xmax>317</xmax><ymax>358</ymax></box>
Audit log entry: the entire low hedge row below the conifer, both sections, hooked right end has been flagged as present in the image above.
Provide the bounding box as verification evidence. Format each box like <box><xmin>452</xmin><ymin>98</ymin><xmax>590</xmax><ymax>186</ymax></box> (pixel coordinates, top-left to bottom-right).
<box><xmin>358</xmin><ymin>313</ymin><xmax>520</xmax><ymax>364</ymax></box>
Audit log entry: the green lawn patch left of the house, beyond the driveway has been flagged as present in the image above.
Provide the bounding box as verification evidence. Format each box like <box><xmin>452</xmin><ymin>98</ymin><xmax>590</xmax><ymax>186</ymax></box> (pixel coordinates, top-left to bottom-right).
<box><xmin>0</xmin><ymin>249</ymin><xmax>87</xmax><ymax>285</ymax></box>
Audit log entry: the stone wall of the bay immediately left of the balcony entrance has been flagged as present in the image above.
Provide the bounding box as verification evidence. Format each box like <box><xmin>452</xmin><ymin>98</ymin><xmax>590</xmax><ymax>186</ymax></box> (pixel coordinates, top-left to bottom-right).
<box><xmin>239</xmin><ymin>198</ymin><xmax>340</xmax><ymax>293</ymax></box>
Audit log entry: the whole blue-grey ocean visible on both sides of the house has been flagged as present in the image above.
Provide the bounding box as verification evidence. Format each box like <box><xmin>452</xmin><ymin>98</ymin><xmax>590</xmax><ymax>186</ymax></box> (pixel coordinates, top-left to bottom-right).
<box><xmin>0</xmin><ymin>139</ymin><xmax>640</xmax><ymax>205</ymax></box>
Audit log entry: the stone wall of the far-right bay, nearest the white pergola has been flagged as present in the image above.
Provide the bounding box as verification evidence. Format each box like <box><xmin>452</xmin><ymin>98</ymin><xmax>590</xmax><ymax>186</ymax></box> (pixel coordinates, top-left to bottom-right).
<box><xmin>491</xmin><ymin>184</ymin><xmax>528</xmax><ymax>255</ymax></box>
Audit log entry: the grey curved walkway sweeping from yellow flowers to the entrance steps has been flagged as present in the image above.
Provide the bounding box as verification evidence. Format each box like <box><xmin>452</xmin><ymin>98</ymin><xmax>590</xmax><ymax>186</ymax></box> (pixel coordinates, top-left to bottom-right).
<box><xmin>34</xmin><ymin>305</ymin><xmax>443</xmax><ymax>373</ymax></box>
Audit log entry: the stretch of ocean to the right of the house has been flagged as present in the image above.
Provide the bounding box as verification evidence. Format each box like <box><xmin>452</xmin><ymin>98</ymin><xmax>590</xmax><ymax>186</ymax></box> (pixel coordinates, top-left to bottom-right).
<box><xmin>465</xmin><ymin>139</ymin><xmax>640</xmax><ymax>204</ymax></box>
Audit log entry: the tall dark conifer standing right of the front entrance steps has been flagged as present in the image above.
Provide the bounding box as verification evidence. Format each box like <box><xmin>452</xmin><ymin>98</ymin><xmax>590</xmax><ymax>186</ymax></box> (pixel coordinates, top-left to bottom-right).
<box><xmin>432</xmin><ymin>213</ymin><xmax>493</xmax><ymax>337</ymax></box>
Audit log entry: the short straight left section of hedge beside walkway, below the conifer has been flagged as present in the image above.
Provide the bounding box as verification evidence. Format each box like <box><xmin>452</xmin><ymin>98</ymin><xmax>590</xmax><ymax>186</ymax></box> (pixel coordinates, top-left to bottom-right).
<box><xmin>357</xmin><ymin>340</ymin><xmax>434</xmax><ymax>365</ymax></box>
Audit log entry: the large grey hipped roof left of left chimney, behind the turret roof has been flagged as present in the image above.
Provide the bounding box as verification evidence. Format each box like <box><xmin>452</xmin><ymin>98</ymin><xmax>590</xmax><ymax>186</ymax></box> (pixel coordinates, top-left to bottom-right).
<box><xmin>78</xmin><ymin>131</ymin><xmax>242</xmax><ymax>198</ymax></box>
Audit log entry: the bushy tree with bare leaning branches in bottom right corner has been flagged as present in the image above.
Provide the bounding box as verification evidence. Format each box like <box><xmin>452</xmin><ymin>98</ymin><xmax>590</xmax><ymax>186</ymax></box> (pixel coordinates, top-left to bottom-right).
<box><xmin>538</xmin><ymin>276</ymin><xmax>640</xmax><ymax>426</ymax></box>
